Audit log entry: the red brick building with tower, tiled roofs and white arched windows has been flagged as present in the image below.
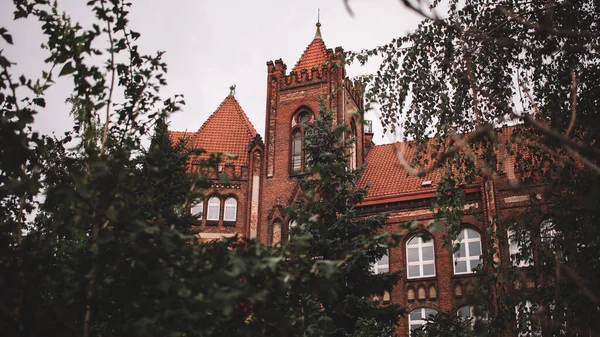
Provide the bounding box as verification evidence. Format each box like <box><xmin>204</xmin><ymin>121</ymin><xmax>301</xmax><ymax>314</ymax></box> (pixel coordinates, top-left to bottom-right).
<box><xmin>171</xmin><ymin>24</ymin><xmax>540</xmax><ymax>336</ymax></box>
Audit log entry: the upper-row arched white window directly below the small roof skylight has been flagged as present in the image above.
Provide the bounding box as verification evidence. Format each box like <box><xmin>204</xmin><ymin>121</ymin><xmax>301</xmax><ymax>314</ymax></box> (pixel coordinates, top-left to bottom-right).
<box><xmin>406</xmin><ymin>235</ymin><xmax>435</xmax><ymax>278</ymax></box>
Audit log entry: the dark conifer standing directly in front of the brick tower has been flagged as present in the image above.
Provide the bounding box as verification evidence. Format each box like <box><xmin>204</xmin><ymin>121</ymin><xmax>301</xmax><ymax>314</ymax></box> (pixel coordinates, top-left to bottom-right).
<box><xmin>289</xmin><ymin>105</ymin><xmax>404</xmax><ymax>336</ymax></box>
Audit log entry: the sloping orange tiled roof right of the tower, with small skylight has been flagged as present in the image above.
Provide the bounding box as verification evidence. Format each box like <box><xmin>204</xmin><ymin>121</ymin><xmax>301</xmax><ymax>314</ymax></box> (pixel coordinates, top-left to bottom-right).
<box><xmin>359</xmin><ymin>143</ymin><xmax>442</xmax><ymax>201</ymax></box>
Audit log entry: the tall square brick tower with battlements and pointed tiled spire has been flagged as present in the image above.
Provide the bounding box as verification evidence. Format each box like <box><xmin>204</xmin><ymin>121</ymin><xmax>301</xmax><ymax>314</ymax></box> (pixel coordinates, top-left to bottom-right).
<box><xmin>257</xmin><ymin>23</ymin><xmax>364</xmax><ymax>244</ymax></box>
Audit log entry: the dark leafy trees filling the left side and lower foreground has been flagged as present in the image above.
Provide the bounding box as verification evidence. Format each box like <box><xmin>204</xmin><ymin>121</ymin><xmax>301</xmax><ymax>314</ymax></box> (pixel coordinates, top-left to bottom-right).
<box><xmin>0</xmin><ymin>0</ymin><xmax>340</xmax><ymax>337</ymax></box>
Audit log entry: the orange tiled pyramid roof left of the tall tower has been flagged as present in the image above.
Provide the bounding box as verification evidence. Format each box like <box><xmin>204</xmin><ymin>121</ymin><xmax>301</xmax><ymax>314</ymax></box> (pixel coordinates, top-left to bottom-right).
<box><xmin>170</xmin><ymin>95</ymin><xmax>257</xmax><ymax>166</ymax></box>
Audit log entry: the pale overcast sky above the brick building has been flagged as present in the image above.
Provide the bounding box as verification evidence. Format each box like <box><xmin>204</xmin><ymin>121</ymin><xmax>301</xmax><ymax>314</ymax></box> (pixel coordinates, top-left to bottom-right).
<box><xmin>0</xmin><ymin>0</ymin><xmax>420</xmax><ymax>144</ymax></box>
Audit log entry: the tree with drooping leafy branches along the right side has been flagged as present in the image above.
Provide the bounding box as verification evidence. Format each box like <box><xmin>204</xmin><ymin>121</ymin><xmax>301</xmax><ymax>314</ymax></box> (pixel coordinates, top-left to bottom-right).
<box><xmin>350</xmin><ymin>0</ymin><xmax>600</xmax><ymax>336</ymax></box>
